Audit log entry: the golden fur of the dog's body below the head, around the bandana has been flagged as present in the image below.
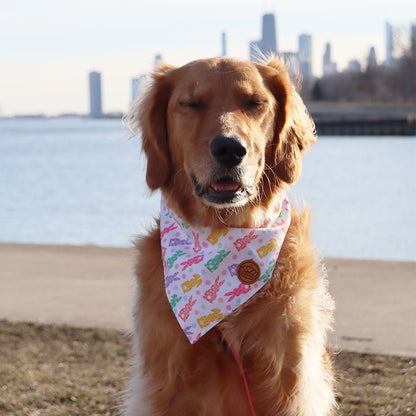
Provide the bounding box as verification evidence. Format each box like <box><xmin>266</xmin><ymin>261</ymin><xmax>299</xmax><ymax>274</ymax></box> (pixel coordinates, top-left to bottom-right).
<box><xmin>127</xmin><ymin>213</ymin><xmax>333</xmax><ymax>416</ymax></box>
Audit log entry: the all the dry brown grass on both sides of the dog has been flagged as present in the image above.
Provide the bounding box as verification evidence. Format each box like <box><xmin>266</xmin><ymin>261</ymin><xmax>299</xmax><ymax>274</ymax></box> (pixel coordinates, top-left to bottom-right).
<box><xmin>0</xmin><ymin>321</ymin><xmax>416</xmax><ymax>416</ymax></box>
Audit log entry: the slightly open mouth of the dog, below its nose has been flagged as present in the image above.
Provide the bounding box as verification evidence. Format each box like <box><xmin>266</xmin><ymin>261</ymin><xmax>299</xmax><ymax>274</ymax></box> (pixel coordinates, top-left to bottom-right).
<box><xmin>192</xmin><ymin>176</ymin><xmax>254</xmax><ymax>205</ymax></box>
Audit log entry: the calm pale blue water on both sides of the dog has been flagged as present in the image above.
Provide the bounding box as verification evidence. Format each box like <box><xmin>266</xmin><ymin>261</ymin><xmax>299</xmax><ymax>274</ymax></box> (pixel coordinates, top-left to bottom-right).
<box><xmin>0</xmin><ymin>119</ymin><xmax>416</xmax><ymax>260</ymax></box>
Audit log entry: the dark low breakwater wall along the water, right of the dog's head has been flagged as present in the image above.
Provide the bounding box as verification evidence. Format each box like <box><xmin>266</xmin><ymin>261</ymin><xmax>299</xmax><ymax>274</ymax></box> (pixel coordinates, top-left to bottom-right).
<box><xmin>307</xmin><ymin>103</ymin><xmax>416</xmax><ymax>136</ymax></box>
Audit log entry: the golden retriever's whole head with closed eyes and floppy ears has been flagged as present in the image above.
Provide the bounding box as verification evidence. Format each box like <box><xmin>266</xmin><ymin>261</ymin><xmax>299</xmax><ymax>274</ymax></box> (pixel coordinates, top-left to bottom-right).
<box><xmin>133</xmin><ymin>58</ymin><xmax>316</xmax><ymax>226</ymax></box>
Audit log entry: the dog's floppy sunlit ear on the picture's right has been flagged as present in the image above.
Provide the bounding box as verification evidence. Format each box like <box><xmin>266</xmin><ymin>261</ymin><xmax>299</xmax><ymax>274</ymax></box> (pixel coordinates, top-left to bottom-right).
<box><xmin>260</xmin><ymin>58</ymin><xmax>316</xmax><ymax>183</ymax></box>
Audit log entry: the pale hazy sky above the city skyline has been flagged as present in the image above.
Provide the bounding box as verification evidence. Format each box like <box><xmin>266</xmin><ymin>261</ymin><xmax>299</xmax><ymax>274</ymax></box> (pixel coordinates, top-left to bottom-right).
<box><xmin>0</xmin><ymin>0</ymin><xmax>416</xmax><ymax>116</ymax></box>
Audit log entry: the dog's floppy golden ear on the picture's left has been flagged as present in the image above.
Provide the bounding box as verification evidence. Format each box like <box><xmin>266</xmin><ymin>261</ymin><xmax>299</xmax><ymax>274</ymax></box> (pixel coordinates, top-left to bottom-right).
<box><xmin>132</xmin><ymin>64</ymin><xmax>174</xmax><ymax>191</ymax></box>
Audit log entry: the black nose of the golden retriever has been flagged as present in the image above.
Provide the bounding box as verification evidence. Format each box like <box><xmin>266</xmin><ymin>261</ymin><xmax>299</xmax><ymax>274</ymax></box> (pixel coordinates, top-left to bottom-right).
<box><xmin>210</xmin><ymin>136</ymin><xmax>247</xmax><ymax>169</ymax></box>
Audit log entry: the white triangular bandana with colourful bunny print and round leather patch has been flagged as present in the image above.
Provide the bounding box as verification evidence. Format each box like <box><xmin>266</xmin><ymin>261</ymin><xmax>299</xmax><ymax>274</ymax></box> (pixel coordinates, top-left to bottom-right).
<box><xmin>160</xmin><ymin>196</ymin><xmax>290</xmax><ymax>344</ymax></box>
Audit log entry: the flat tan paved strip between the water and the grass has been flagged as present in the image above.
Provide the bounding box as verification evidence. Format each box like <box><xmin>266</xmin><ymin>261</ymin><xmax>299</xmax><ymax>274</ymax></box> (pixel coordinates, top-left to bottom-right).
<box><xmin>0</xmin><ymin>244</ymin><xmax>416</xmax><ymax>357</ymax></box>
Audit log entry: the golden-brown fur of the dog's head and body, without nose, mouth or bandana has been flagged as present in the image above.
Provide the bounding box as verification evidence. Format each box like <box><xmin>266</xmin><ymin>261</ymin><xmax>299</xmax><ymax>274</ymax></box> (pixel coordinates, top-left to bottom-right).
<box><xmin>125</xmin><ymin>58</ymin><xmax>334</xmax><ymax>416</ymax></box>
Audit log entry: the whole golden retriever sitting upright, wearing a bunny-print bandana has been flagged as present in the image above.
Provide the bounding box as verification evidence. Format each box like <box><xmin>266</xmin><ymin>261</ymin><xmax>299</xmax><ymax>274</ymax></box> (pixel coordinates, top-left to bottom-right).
<box><xmin>124</xmin><ymin>57</ymin><xmax>335</xmax><ymax>416</ymax></box>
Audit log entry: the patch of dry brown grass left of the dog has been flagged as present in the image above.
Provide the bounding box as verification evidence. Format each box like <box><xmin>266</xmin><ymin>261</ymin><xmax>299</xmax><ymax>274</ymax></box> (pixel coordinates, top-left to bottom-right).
<box><xmin>0</xmin><ymin>321</ymin><xmax>129</xmax><ymax>416</ymax></box>
